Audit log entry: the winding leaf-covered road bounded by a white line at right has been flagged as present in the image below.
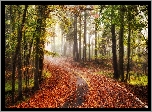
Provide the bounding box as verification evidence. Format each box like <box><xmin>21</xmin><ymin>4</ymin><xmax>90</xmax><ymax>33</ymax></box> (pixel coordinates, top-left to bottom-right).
<box><xmin>45</xmin><ymin>56</ymin><xmax>148</xmax><ymax>108</ymax></box>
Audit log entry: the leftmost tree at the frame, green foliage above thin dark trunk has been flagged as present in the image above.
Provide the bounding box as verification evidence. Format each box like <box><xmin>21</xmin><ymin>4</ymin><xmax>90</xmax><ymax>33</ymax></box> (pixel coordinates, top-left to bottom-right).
<box><xmin>5</xmin><ymin>5</ymin><xmax>18</xmax><ymax>104</ymax></box>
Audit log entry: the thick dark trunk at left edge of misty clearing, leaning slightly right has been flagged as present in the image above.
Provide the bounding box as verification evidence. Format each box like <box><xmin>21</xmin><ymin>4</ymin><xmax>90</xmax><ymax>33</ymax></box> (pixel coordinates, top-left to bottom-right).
<box><xmin>34</xmin><ymin>5</ymin><xmax>47</xmax><ymax>90</ymax></box>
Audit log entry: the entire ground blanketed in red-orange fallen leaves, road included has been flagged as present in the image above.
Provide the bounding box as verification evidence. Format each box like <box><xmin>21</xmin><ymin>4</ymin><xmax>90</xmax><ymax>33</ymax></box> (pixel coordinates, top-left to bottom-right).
<box><xmin>7</xmin><ymin>56</ymin><xmax>148</xmax><ymax>108</ymax></box>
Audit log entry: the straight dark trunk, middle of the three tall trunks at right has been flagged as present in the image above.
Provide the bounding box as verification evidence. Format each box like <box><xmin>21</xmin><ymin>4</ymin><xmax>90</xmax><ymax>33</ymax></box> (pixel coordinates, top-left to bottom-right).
<box><xmin>119</xmin><ymin>5</ymin><xmax>125</xmax><ymax>81</ymax></box>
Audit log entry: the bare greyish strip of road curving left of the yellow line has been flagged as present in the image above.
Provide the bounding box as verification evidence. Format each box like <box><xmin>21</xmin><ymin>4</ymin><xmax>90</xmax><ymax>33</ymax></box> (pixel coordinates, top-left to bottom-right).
<box><xmin>45</xmin><ymin>57</ymin><xmax>88</xmax><ymax>108</ymax></box>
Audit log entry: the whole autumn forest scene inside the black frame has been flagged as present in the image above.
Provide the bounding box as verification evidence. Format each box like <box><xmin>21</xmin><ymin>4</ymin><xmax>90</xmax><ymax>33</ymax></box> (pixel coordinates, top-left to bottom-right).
<box><xmin>2</xmin><ymin>5</ymin><xmax>149</xmax><ymax>108</ymax></box>
